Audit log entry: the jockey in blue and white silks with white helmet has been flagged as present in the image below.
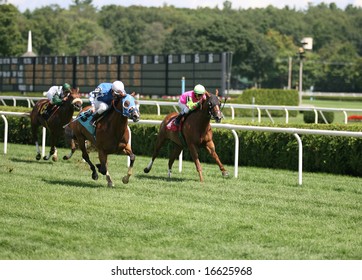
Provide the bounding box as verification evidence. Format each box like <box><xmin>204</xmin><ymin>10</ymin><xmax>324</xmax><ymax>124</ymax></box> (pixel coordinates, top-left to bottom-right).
<box><xmin>89</xmin><ymin>81</ymin><xmax>127</xmax><ymax>127</ymax></box>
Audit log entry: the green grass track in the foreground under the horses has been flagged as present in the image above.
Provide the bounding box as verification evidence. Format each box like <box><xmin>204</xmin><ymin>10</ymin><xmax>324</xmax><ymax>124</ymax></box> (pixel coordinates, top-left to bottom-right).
<box><xmin>0</xmin><ymin>144</ymin><xmax>362</xmax><ymax>260</ymax></box>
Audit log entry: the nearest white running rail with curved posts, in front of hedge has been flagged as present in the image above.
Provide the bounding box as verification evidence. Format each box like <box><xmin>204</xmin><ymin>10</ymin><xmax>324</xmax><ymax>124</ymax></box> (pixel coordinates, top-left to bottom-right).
<box><xmin>0</xmin><ymin>111</ymin><xmax>362</xmax><ymax>185</ymax></box>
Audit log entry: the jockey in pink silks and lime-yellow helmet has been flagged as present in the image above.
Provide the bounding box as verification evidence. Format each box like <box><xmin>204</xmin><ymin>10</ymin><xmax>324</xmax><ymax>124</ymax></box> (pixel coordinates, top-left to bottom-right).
<box><xmin>174</xmin><ymin>84</ymin><xmax>206</xmax><ymax>126</ymax></box>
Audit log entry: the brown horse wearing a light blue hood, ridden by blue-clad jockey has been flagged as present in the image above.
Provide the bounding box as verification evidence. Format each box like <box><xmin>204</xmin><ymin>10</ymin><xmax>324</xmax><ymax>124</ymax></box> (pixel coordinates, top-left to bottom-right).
<box><xmin>63</xmin><ymin>94</ymin><xmax>140</xmax><ymax>187</ymax></box>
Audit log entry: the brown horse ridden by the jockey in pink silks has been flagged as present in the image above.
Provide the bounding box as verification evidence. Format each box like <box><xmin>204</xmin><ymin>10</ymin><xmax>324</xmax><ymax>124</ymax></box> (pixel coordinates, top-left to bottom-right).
<box><xmin>144</xmin><ymin>93</ymin><xmax>229</xmax><ymax>182</ymax></box>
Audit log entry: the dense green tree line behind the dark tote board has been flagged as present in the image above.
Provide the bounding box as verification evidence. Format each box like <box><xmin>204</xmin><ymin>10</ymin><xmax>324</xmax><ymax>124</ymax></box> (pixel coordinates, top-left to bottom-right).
<box><xmin>0</xmin><ymin>0</ymin><xmax>362</xmax><ymax>92</ymax></box>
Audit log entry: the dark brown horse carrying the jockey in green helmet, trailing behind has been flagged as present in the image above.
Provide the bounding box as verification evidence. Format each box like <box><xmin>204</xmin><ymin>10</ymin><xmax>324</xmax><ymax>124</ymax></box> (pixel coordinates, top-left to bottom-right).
<box><xmin>30</xmin><ymin>89</ymin><xmax>83</xmax><ymax>161</ymax></box>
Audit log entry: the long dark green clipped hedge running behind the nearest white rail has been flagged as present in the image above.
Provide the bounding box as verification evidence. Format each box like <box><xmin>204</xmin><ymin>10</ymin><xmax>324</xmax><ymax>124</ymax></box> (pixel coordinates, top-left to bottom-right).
<box><xmin>0</xmin><ymin>117</ymin><xmax>362</xmax><ymax>176</ymax></box>
